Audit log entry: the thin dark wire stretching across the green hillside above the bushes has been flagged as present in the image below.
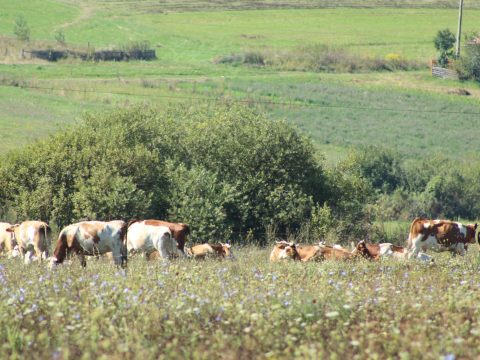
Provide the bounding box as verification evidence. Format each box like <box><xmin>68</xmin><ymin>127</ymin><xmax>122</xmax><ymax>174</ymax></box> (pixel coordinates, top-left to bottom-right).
<box><xmin>0</xmin><ymin>85</ymin><xmax>480</xmax><ymax>115</ymax></box>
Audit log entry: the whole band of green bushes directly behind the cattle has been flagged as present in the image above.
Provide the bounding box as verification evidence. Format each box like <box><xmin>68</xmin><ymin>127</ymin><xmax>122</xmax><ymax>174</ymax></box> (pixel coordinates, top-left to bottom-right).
<box><xmin>0</xmin><ymin>104</ymin><xmax>480</xmax><ymax>242</ymax></box>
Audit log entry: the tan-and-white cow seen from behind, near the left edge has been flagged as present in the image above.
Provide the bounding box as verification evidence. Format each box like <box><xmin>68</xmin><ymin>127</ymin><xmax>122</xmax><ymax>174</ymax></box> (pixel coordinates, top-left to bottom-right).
<box><xmin>6</xmin><ymin>221</ymin><xmax>52</xmax><ymax>264</ymax></box>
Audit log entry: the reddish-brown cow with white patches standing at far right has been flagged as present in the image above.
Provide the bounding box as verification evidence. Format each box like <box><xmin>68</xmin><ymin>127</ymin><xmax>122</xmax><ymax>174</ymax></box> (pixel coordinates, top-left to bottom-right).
<box><xmin>408</xmin><ymin>218</ymin><xmax>480</xmax><ymax>258</ymax></box>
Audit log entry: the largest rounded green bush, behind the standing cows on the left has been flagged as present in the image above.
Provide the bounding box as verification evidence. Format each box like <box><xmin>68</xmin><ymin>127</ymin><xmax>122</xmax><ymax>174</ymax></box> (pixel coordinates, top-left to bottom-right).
<box><xmin>0</xmin><ymin>105</ymin><xmax>328</xmax><ymax>240</ymax></box>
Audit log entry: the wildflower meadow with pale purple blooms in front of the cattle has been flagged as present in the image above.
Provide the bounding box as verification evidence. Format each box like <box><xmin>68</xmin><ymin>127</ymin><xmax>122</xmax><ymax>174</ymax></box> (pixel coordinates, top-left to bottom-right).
<box><xmin>0</xmin><ymin>248</ymin><xmax>480</xmax><ymax>359</ymax></box>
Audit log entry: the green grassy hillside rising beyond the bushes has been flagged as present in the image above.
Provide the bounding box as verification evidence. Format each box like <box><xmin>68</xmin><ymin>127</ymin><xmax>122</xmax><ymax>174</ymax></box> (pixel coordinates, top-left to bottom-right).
<box><xmin>0</xmin><ymin>0</ymin><xmax>480</xmax><ymax>160</ymax></box>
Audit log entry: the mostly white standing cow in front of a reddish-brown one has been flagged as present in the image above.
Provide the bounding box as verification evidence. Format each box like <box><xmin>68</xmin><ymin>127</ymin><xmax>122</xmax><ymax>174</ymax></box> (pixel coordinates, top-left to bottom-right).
<box><xmin>127</xmin><ymin>221</ymin><xmax>185</xmax><ymax>259</ymax></box>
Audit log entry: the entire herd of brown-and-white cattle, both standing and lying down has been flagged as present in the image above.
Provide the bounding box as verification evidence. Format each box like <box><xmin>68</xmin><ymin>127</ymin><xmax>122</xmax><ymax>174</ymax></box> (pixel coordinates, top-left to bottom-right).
<box><xmin>0</xmin><ymin>218</ymin><xmax>480</xmax><ymax>267</ymax></box>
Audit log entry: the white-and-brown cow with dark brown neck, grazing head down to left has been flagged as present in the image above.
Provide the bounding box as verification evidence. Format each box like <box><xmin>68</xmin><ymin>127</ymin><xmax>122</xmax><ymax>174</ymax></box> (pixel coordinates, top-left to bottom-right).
<box><xmin>51</xmin><ymin>220</ymin><xmax>127</xmax><ymax>267</ymax></box>
